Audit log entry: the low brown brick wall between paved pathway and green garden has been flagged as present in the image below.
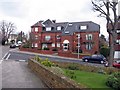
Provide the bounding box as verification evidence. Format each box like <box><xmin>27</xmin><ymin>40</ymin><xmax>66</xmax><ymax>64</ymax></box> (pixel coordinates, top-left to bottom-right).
<box><xmin>28</xmin><ymin>59</ymin><xmax>84</xmax><ymax>90</ymax></box>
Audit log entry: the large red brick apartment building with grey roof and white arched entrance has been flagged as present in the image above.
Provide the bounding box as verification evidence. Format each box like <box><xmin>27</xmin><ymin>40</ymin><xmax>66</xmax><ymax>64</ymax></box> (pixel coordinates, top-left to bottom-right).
<box><xmin>31</xmin><ymin>19</ymin><xmax>100</xmax><ymax>54</ymax></box>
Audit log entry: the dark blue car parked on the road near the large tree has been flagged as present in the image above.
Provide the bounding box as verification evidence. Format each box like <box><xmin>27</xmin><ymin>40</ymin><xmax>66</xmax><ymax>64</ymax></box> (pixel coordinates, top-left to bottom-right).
<box><xmin>82</xmin><ymin>54</ymin><xmax>106</xmax><ymax>64</ymax></box>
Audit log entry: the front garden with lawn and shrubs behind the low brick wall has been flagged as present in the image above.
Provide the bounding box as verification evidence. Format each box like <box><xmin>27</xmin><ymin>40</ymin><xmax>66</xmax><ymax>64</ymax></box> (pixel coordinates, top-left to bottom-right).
<box><xmin>29</xmin><ymin>56</ymin><xmax>120</xmax><ymax>90</ymax></box>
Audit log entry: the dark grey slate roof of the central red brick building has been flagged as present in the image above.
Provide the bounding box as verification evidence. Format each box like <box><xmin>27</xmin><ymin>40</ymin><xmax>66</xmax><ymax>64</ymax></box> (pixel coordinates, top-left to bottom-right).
<box><xmin>33</xmin><ymin>19</ymin><xmax>100</xmax><ymax>35</ymax></box>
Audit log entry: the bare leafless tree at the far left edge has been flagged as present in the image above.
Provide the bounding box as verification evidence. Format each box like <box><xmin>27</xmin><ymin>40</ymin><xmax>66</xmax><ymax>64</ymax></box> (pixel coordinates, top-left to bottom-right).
<box><xmin>0</xmin><ymin>20</ymin><xmax>16</xmax><ymax>45</ymax></box>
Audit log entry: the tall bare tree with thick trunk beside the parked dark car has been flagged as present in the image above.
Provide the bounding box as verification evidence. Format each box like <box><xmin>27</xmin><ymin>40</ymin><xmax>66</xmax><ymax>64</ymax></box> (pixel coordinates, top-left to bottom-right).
<box><xmin>92</xmin><ymin>0</ymin><xmax>120</xmax><ymax>66</ymax></box>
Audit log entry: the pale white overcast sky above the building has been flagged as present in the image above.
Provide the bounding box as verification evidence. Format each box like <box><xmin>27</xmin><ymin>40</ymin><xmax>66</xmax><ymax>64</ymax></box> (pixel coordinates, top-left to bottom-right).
<box><xmin>0</xmin><ymin>0</ymin><xmax>108</xmax><ymax>36</ymax></box>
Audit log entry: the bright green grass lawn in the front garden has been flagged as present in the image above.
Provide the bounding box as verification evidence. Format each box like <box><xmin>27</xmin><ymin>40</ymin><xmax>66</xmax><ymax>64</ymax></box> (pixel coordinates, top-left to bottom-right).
<box><xmin>64</xmin><ymin>69</ymin><xmax>112</xmax><ymax>90</ymax></box>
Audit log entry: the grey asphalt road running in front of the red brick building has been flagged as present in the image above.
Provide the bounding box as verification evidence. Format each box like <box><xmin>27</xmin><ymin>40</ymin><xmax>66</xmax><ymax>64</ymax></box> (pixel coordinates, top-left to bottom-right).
<box><xmin>4</xmin><ymin>49</ymin><xmax>104</xmax><ymax>67</ymax></box>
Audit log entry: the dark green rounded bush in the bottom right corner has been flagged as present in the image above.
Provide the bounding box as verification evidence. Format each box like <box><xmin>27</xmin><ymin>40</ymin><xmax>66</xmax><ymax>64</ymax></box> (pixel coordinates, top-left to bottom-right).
<box><xmin>106</xmin><ymin>72</ymin><xmax>120</xmax><ymax>90</ymax></box>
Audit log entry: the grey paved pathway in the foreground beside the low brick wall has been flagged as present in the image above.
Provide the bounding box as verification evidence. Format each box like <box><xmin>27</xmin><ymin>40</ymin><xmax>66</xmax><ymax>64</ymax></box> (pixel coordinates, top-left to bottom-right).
<box><xmin>2</xmin><ymin>60</ymin><xmax>45</xmax><ymax>88</ymax></box>
